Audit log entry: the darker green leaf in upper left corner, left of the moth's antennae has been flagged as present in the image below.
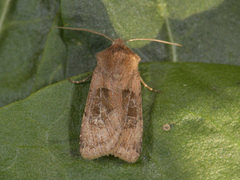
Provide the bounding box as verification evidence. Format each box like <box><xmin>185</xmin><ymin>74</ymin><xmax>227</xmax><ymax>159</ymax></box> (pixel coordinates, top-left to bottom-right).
<box><xmin>0</xmin><ymin>0</ymin><xmax>64</xmax><ymax>106</ymax></box>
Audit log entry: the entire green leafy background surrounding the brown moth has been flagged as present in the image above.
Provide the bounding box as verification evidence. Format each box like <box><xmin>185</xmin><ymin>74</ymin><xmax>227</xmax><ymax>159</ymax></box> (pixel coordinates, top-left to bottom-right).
<box><xmin>0</xmin><ymin>0</ymin><xmax>240</xmax><ymax>179</ymax></box>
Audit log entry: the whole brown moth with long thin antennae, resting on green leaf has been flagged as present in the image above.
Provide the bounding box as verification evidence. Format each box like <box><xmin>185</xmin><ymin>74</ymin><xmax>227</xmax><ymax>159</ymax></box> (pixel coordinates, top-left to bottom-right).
<box><xmin>59</xmin><ymin>27</ymin><xmax>179</xmax><ymax>163</ymax></box>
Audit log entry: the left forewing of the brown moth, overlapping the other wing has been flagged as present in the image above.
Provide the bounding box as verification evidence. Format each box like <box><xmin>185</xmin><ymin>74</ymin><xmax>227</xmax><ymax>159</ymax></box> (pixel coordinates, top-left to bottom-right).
<box><xmin>80</xmin><ymin>66</ymin><xmax>121</xmax><ymax>159</ymax></box>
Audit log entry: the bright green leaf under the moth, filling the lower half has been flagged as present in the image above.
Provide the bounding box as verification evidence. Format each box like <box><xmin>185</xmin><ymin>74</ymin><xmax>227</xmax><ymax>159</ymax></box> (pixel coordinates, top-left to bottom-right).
<box><xmin>0</xmin><ymin>63</ymin><xmax>240</xmax><ymax>179</ymax></box>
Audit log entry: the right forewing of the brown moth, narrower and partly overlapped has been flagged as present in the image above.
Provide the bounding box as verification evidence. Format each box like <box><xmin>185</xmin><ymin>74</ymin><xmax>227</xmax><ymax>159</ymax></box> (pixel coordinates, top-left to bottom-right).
<box><xmin>112</xmin><ymin>71</ymin><xmax>143</xmax><ymax>163</ymax></box>
